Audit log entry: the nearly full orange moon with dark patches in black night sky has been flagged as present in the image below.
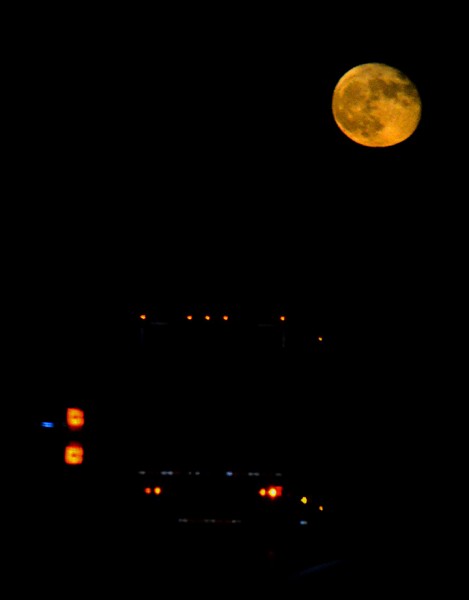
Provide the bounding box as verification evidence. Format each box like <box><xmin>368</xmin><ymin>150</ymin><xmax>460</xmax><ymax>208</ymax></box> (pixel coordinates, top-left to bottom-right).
<box><xmin>332</xmin><ymin>63</ymin><xmax>422</xmax><ymax>148</ymax></box>
